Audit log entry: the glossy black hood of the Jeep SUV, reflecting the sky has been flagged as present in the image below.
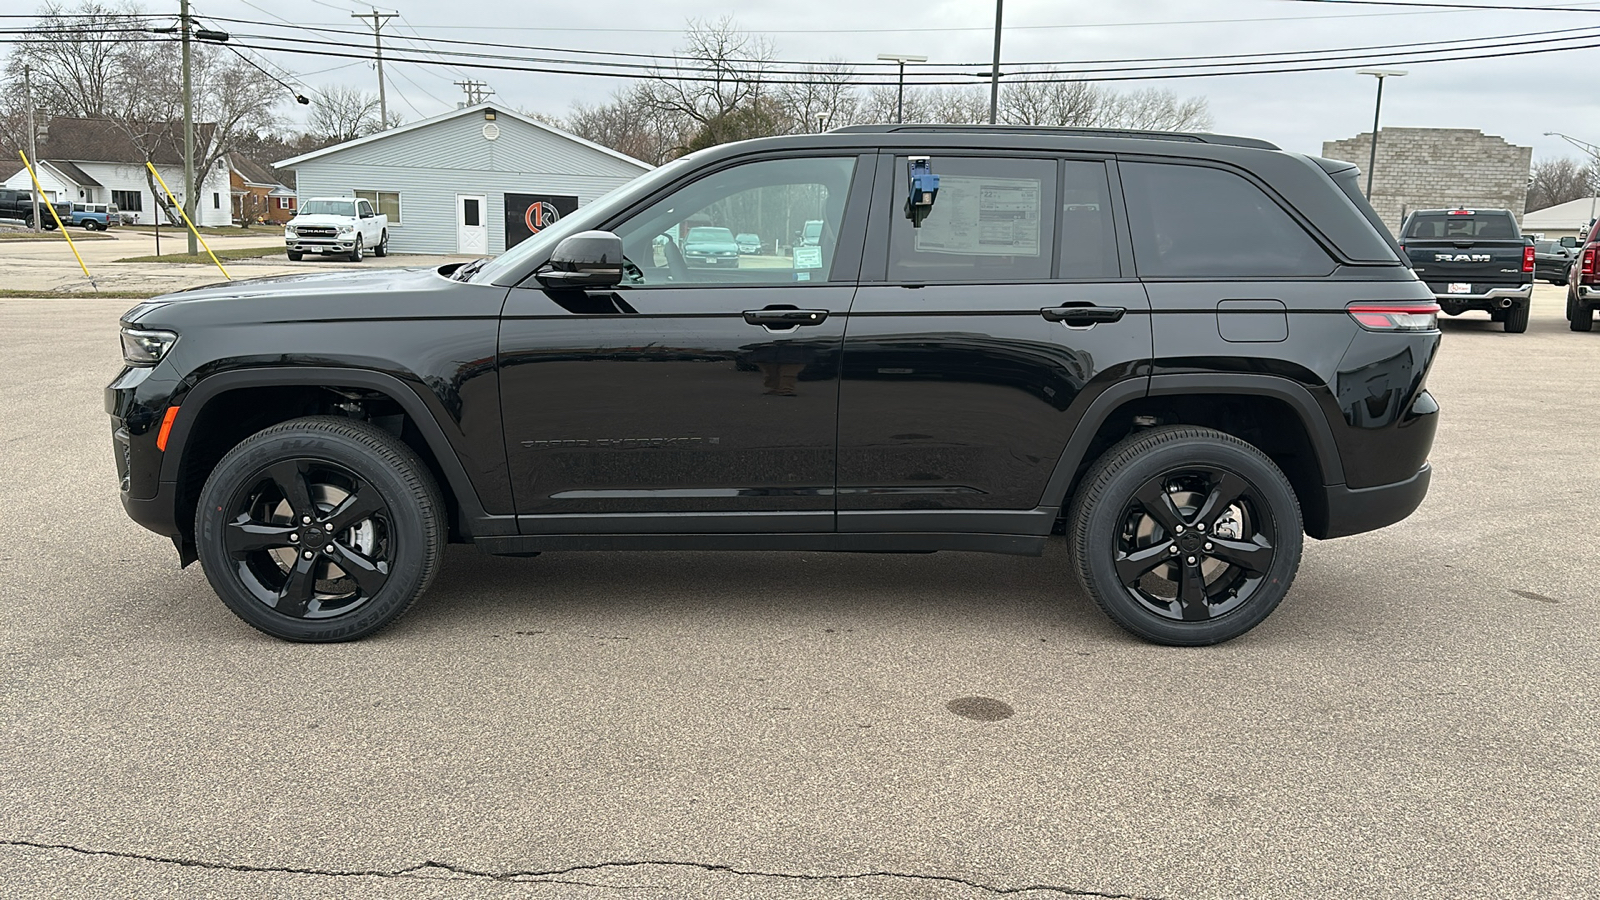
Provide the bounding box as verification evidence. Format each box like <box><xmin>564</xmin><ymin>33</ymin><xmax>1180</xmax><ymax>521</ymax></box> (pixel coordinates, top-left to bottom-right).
<box><xmin>122</xmin><ymin>263</ymin><xmax>470</xmax><ymax>328</ymax></box>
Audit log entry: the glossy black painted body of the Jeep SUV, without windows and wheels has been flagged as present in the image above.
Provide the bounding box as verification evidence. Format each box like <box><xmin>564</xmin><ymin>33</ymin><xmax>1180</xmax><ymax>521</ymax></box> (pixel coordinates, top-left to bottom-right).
<box><xmin>106</xmin><ymin>130</ymin><xmax>1438</xmax><ymax>559</ymax></box>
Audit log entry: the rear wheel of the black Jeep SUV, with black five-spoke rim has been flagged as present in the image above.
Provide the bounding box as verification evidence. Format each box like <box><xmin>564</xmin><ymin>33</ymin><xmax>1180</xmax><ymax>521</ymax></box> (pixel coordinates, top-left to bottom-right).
<box><xmin>1067</xmin><ymin>426</ymin><xmax>1302</xmax><ymax>647</ymax></box>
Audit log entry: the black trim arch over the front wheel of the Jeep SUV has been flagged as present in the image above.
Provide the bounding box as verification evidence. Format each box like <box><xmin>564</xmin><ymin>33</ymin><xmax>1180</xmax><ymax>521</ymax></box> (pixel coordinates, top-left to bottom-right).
<box><xmin>160</xmin><ymin>367</ymin><xmax>515</xmax><ymax>559</ymax></box>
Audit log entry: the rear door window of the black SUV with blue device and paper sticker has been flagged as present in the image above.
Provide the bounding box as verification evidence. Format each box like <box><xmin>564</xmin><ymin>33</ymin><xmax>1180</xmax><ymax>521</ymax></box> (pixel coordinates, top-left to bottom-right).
<box><xmin>888</xmin><ymin>155</ymin><xmax>1056</xmax><ymax>282</ymax></box>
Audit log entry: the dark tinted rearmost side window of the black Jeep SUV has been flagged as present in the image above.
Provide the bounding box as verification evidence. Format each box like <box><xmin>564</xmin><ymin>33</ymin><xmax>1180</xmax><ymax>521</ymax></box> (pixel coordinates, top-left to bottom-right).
<box><xmin>1120</xmin><ymin>162</ymin><xmax>1334</xmax><ymax>277</ymax></box>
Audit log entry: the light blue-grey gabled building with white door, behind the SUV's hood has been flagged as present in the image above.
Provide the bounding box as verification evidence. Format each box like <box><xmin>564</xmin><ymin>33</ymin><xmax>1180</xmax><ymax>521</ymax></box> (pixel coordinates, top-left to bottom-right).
<box><xmin>274</xmin><ymin>102</ymin><xmax>651</xmax><ymax>256</ymax></box>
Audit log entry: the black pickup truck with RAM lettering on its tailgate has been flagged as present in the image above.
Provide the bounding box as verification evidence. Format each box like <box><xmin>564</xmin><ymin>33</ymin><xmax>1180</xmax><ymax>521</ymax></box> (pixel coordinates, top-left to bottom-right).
<box><xmin>1400</xmin><ymin>208</ymin><xmax>1534</xmax><ymax>335</ymax></box>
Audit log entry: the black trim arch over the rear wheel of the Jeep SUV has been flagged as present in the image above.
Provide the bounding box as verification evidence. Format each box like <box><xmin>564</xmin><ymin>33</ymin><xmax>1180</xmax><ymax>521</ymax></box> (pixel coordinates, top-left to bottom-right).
<box><xmin>1042</xmin><ymin>373</ymin><xmax>1344</xmax><ymax>536</ymax></box>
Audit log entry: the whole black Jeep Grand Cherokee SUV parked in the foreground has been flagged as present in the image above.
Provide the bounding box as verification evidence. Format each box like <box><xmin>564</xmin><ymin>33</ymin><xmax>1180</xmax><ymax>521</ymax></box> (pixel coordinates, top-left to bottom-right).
<box><xmin>106</xmin><ymin>127</ymin><xmax>1438</xmax><ymax>644</ymax></box>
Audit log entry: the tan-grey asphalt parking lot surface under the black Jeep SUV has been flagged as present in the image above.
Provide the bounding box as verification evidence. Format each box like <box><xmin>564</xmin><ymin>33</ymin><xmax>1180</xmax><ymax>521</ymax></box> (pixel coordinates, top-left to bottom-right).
<box><xmin>0</xmin><ymin>285</ymin><xmax>1600</xmax><ymax>900</ymax></box>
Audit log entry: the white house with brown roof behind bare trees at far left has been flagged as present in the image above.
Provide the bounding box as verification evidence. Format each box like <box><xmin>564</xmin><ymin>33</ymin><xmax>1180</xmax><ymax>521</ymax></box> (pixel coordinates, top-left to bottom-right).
<box><xmin>5</xmin><ymin>117</ymin><xmax>234</xmax><ymax>226</ymax></box>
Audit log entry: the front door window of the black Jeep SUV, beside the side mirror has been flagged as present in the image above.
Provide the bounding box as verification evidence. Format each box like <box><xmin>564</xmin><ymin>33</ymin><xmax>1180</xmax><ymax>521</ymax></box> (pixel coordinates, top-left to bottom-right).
<box><xmin>611</xmin><ymin>157</ymin><xmax>856</xmax><ymax>287</ymax></box>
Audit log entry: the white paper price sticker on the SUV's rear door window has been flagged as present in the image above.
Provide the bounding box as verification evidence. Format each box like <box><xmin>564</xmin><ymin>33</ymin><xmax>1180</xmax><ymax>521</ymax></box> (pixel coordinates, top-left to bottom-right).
<box><xmin>921</xmin><ymin>175</ymin><xmax>1045</xmax><ymax>257</ymax></box>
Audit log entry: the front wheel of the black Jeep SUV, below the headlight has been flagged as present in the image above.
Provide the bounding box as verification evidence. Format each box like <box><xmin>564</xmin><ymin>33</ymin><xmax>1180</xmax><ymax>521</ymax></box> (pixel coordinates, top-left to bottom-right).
<box><xmin>195</xmin><ymin>416</ymin><xmax>445</xmax><ymax>642</ymax></box>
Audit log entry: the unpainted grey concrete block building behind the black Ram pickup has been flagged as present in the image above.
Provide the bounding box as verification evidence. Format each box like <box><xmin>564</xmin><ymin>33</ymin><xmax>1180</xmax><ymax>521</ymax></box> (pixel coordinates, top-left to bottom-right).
<box><xmin>1322</xmin><ymin>128</ymin><xmax>1533</xmax><ymax>232</ymax></box>
